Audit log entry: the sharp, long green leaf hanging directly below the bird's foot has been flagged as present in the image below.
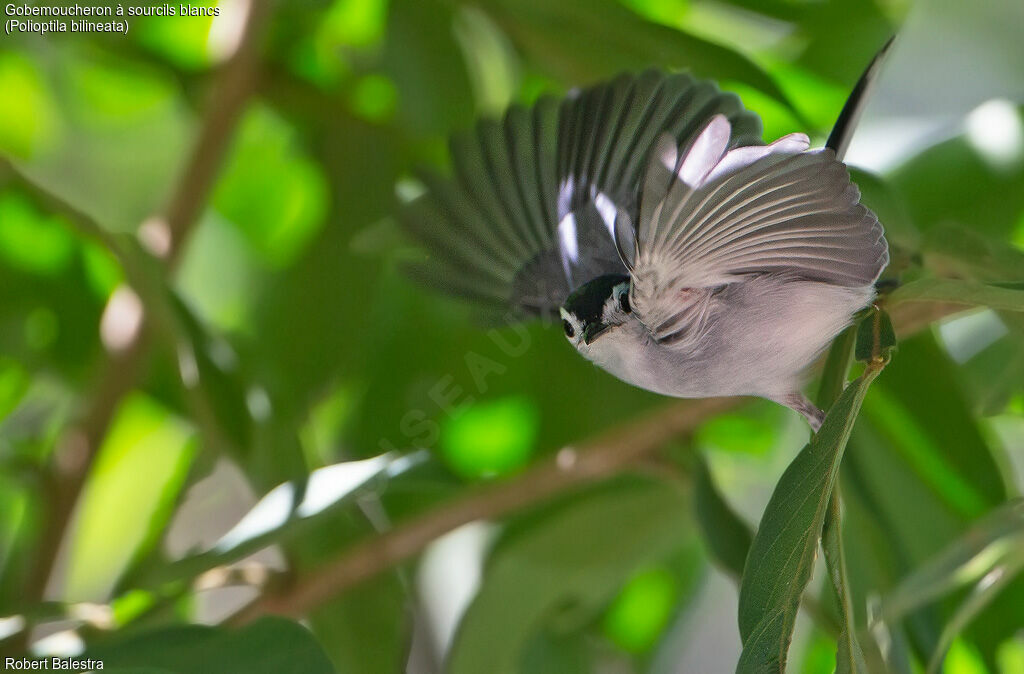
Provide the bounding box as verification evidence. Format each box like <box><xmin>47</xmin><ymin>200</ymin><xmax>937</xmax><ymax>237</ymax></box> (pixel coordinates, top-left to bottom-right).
<box><xmin>736</xmin><ymin>366</ymin><xmax>881</xmax><ymax>673</ymax></box>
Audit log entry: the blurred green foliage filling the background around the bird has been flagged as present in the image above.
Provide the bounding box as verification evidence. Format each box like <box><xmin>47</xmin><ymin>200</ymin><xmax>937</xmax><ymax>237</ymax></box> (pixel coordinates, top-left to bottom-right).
<box><xmin>0</xmin><ymin>0</ymin><xmax>1024</xmax><ymax>674</ymax></box>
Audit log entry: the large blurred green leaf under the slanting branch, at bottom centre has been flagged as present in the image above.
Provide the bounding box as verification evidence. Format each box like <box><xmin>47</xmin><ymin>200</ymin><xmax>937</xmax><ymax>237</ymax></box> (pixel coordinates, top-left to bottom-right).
<box><xmin>446</xmin><ymin>480</ymin><xmax>686</xmax><ymax>674</ymax></box>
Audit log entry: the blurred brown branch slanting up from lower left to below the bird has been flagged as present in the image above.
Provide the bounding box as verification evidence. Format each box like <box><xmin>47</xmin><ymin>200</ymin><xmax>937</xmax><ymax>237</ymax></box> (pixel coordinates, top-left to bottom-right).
<box><xmin>229</xmin><ymin>397</ymin><xmax>740</xmax><ymax>624</ymax></box>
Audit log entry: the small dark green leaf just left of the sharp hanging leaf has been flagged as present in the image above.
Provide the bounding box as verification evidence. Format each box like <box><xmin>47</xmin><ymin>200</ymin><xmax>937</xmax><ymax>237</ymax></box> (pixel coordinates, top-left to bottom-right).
<box><xmin>693</xmin><ymin>457</ymin><xmax>752</xmax><ymax>579</ymax></box>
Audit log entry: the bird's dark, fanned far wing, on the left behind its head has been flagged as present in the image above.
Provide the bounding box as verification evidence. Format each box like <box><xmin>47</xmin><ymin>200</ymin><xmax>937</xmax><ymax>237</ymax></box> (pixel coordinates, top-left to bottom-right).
<box><xmin>400</xmin><ymin>71</ymin><xmax>761</xmax><ymax>314</ymax></box>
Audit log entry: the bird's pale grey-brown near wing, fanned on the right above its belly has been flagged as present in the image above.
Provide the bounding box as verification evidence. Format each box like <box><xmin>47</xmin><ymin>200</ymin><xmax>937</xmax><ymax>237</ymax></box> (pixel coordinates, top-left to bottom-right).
<box><xmin>616</xmin><ymin>117</ymin><xmax>889</xmax><ymax>341</ymax></box>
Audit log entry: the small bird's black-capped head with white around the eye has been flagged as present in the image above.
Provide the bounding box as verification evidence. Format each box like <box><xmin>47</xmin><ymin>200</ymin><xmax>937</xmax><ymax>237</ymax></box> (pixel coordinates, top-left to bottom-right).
<box><xmin>560</xmin><ymin>273</ymin><xmax>632</xmax><ymax>351</ymax></box>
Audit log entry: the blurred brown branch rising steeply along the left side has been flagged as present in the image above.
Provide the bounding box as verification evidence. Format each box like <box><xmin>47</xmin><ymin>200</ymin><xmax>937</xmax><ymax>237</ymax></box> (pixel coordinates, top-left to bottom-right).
<box><xmin>16</xmin><ymin>0</ymin><xmax>268</xmax><ymax>618</ymax></box>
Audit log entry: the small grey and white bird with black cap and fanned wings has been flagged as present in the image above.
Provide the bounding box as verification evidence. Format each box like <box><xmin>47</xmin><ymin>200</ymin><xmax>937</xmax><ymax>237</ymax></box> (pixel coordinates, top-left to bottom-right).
<box><xmin>399</xmin><ymin>41</ymin><xmax>891</xmax><ymax>432</ymax></box>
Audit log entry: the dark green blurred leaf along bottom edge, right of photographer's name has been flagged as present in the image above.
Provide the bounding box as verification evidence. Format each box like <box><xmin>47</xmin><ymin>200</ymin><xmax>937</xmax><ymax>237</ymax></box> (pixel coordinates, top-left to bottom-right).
<box><xmin>82</xmin><ymin>618</ymin><xmax>335</xmax><ymax>674</ymax></box>
